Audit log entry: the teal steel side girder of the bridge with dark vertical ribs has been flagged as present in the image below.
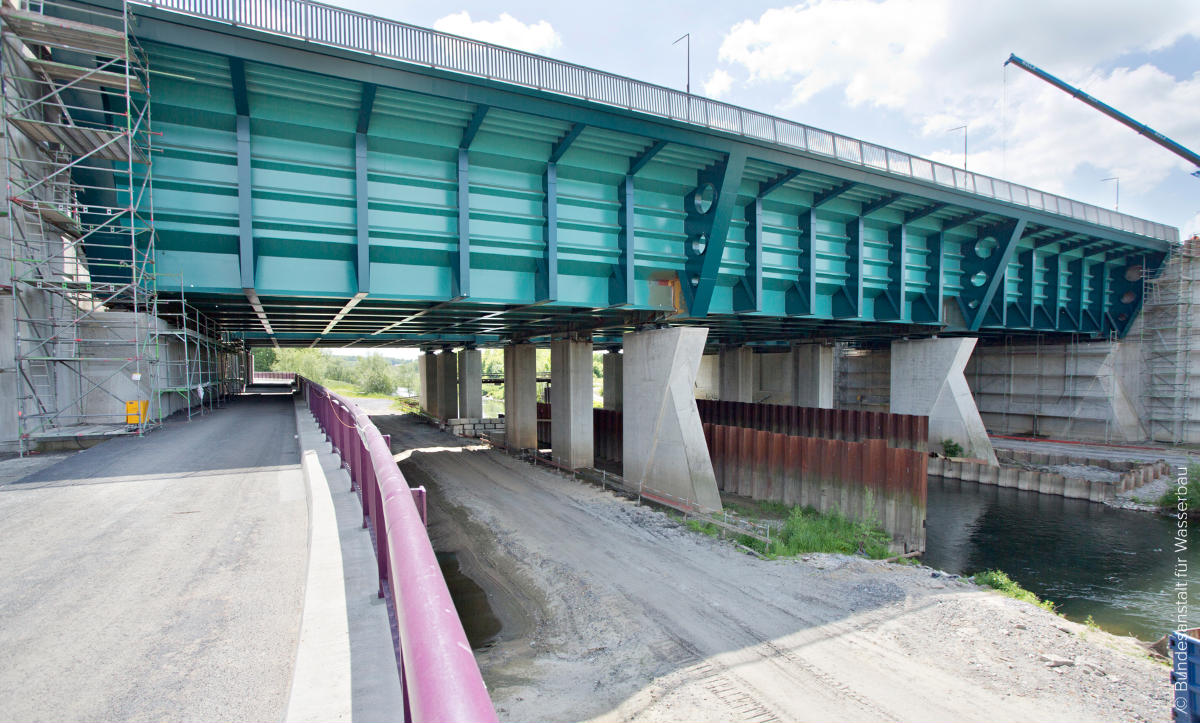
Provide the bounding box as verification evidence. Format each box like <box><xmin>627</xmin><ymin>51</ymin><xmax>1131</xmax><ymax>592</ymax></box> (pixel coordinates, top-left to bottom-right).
<box><xmin>82</xmin><ymin>0</ymin><xmax>1169</xmax><ymax>347</ymax></box>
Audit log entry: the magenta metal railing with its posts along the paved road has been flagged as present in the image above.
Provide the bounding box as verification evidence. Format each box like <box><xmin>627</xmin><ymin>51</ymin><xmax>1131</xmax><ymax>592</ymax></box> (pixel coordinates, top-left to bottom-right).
<box><xmin>299</xmin><ymin>377</ymin><xmax>497</xmax><ymax>723</ymax></box>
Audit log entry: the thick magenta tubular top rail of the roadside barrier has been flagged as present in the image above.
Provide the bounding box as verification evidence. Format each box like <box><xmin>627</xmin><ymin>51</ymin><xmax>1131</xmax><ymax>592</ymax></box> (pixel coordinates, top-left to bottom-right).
<box><xmin>308</xmin><ymin>382</ymin><xmax>497</xmax><ymax>723</ymax></box>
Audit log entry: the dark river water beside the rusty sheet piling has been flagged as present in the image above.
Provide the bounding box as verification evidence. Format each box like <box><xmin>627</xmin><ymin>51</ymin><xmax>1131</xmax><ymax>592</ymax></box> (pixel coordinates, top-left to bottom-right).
<box><xmin>922</xmin><ymin>477</ymin><xmax>1200</xmax><ymax>640</ymax></box>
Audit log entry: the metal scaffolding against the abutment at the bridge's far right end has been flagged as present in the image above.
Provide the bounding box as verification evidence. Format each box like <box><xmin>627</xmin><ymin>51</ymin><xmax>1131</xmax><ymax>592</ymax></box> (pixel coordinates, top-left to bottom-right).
<box><xmin>1141</xmin><ymin>237</ymin><xmax>1200</xmax><ymax>444</ymax></box>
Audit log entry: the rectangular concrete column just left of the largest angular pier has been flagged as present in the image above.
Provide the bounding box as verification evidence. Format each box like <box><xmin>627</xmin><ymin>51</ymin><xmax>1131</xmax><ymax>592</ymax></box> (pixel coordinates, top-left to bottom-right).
<box><xmin>550</xmin><ymin>339</ymin><xmax>595</xmax><ymax>468</ymax></box>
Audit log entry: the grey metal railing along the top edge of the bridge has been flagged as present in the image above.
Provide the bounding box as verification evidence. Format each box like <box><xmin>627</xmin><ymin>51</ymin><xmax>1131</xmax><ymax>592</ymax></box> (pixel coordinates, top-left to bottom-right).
<box><xmin>131</xmin><ymin>0</ymin><xmax>1180</xmax><ymax>243</ymax></box>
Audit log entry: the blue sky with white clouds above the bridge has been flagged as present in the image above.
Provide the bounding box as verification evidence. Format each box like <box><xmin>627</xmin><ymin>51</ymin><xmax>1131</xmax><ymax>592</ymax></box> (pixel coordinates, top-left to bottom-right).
<box><xmin>319</xmin><ymin>0</ymin><xmax>1200</xmax><ymax>357</ymax></box>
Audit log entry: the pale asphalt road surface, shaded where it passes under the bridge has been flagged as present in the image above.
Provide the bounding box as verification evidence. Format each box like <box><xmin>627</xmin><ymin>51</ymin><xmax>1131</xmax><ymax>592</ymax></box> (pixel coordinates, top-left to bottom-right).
<box><xmin>0</xmin><ymin>395</ymin><xmax>307</xmax><ymax>721</ymax></box>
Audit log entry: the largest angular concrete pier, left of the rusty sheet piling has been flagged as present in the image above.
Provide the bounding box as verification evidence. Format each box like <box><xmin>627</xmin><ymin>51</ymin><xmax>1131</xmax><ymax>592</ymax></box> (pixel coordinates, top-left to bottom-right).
<box><xmin>624</xmin><ymin>327</ymin><xmax>715</xmax><ymax>510</ymax></box>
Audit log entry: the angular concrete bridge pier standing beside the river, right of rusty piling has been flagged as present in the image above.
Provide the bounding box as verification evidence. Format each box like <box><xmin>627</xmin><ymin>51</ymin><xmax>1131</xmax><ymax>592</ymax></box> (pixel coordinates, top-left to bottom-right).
<box><xmin>892</xmin><ymin>339</ymin><xmax>1000</xmax><ymax>465</ymax></box>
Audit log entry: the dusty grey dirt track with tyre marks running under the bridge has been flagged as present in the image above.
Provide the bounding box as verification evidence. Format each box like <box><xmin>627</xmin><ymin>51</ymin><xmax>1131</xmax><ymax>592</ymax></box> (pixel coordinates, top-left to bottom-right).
<box><xmin>376</xmin><ymin>417</ymin><xmax>1170</xmax><ymax>722</ymax></box>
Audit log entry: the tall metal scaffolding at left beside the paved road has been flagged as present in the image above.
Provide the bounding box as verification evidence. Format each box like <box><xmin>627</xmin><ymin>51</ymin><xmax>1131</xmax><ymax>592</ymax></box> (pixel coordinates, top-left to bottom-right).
<box><xmin>0</xmin><ymin>1</ymin><xmax>161</xmax><ymax>452</ymax></box>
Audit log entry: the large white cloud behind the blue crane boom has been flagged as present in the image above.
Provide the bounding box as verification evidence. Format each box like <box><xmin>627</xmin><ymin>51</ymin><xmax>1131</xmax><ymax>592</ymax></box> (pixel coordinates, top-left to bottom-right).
<box><xmin>720</xmin><ymin>0</ymin><xmax>1200</xmax><ymax>202</ymax></box>
